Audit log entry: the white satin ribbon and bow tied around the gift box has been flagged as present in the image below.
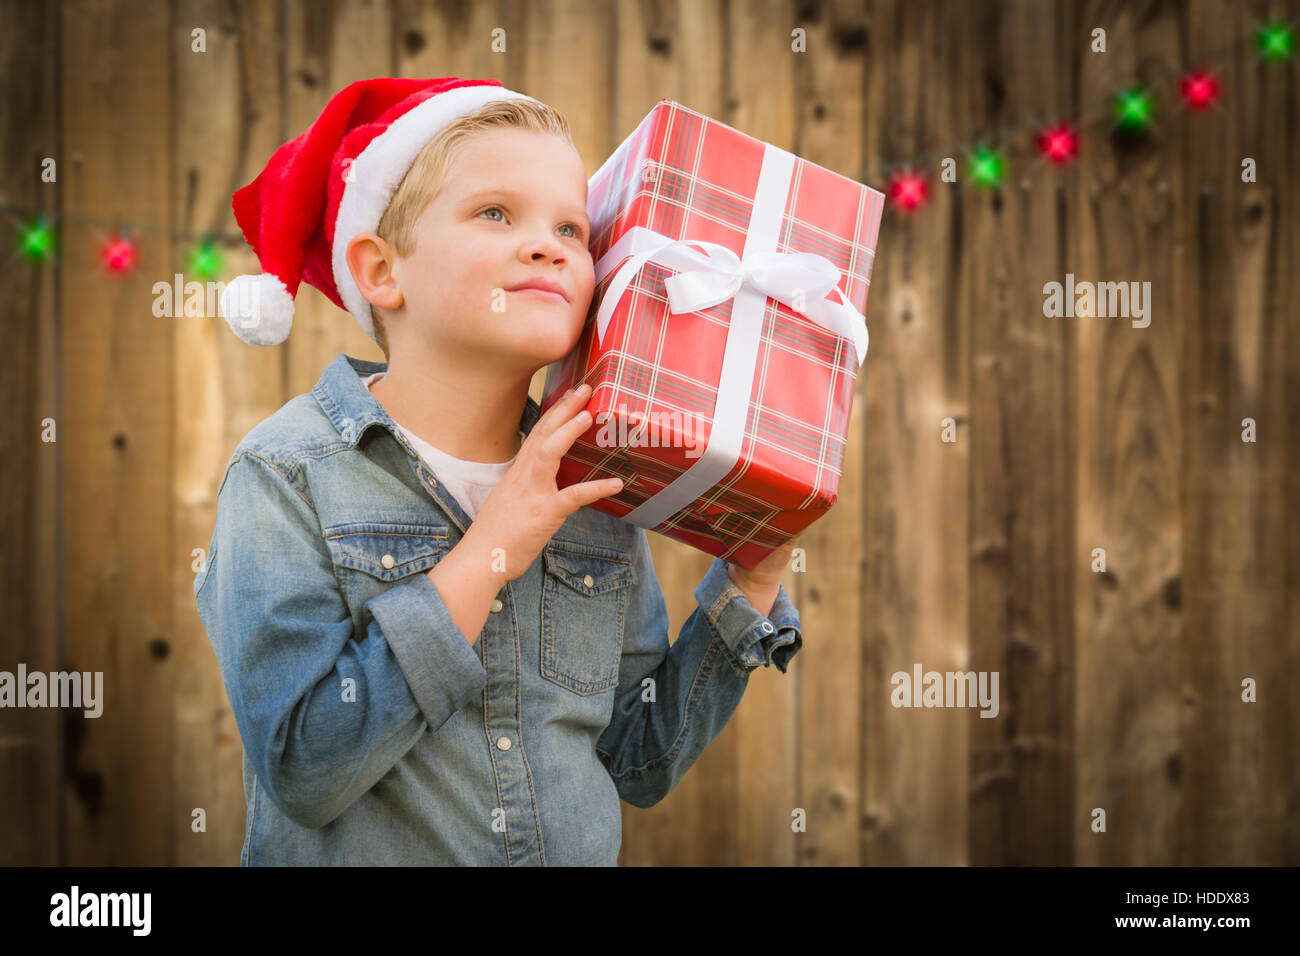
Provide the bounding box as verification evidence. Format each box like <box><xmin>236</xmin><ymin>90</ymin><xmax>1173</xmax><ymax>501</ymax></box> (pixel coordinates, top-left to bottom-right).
<box><xmin>585</xmin><ymin>144</ymin><xmax>867</xmax><ymax>529</ymax></box>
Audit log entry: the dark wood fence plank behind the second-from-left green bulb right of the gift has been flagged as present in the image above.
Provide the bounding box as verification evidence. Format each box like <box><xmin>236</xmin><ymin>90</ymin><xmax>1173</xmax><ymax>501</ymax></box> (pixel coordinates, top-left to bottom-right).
<box><xmin>967</xmin><ymin>0</ymin><xmax>1076</xmax><ymax>866</ymax></box>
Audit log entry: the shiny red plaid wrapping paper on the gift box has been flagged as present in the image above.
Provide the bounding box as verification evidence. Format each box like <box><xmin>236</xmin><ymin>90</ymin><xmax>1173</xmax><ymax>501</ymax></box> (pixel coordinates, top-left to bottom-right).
<box><xmin>542</xmin><ymin>100</ymin><xmax>884</xmax><ymax>568</ymax></box>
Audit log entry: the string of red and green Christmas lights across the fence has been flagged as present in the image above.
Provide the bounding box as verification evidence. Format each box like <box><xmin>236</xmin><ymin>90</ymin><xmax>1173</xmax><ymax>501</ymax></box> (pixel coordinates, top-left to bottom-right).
<box><xmin>0</xmin><ymin>22</ymin><xmax>1295</xmax><ymax>281</ymax></box>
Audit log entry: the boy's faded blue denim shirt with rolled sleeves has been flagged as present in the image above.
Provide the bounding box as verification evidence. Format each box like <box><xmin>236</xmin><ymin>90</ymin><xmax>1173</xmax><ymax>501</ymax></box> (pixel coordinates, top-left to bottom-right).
<box><xmin>194</xmin><ymin>354</ymin><xmax>802</xmax><ymax>866</ymax></box>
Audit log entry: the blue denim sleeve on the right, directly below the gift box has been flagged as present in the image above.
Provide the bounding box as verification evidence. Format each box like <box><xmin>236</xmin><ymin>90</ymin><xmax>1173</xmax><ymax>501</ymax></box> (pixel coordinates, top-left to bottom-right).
<box><xmin>595</xmin><ymin>529</ymin><xmax>803</xmax><ymax>808</ymax></box>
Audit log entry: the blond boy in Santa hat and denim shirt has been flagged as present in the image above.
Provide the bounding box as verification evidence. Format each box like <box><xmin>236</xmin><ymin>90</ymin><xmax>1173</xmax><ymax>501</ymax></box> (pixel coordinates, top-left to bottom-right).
<box><xmin>194</xmin><ymin>78</ymin><xmax>802</xmax><ymax>865</ymax></box>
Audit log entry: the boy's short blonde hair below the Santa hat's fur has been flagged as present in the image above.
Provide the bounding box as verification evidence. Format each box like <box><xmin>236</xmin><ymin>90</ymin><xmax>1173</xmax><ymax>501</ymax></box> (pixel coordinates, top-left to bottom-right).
<box><xmin>371</xmin><ymin>100</ymin><xmax>577</xmax><ymax>358</ymax></box>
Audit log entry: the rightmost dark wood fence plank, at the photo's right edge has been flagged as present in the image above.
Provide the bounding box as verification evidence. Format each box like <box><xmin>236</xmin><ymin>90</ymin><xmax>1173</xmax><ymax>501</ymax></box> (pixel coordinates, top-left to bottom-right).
<box><xmin>1185</xmin><ymin>3</ymin><xmax>1300</xmax><ymax>866</ymax></box>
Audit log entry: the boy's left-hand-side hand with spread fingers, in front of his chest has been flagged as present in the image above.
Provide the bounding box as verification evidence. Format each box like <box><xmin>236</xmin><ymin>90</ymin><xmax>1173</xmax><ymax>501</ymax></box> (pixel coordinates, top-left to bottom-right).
<box><xmin>465</xmin><ymin>382</ymin><xmax>623</xmax><ymax>583</ymax></box>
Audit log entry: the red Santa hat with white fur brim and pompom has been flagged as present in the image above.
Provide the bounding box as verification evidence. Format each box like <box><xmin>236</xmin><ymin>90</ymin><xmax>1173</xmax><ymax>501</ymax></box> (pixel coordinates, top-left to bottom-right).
<box><xmin>221</xmin><ymin>77</ymin><xmax>537</xmax><ymax>345</ymax></box>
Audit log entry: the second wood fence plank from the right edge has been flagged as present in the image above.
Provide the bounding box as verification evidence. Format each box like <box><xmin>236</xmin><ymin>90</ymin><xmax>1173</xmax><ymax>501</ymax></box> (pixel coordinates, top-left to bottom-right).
<box><xmin>1058</xmin><ymin>4</ymin><xmax>1188</xmax><ymax>865</ymax></box>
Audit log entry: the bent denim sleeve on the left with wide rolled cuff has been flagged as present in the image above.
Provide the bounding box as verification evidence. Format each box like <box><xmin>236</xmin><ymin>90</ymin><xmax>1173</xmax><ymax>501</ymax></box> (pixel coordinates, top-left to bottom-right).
<box><xmin>194</xmin><ymin>450</ymin><xmax>486</xmax><ymax>827</ymax></box>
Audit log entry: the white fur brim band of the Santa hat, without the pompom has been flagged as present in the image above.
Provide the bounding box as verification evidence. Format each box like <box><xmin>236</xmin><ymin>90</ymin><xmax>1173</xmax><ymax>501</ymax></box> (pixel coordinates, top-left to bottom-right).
<box><xmin>335</xmin><ymin>86</ymin><xmax>537</xmax><ymax>338</ymax></box>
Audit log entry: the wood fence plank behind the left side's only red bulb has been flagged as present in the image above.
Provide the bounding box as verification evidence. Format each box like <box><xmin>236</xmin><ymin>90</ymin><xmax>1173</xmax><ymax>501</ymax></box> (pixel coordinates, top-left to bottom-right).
<box><xmin>59</xmin><ymin>0</ymin><xmax>179</xmax><ymax>866</ymax></box>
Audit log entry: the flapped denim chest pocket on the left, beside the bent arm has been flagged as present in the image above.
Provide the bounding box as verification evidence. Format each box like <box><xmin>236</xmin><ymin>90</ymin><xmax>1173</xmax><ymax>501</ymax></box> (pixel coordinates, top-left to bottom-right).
<box><xmin>324</xmin><ymin>522</ymin><xmax>451</xmax><ymax>607</ymax></box>
